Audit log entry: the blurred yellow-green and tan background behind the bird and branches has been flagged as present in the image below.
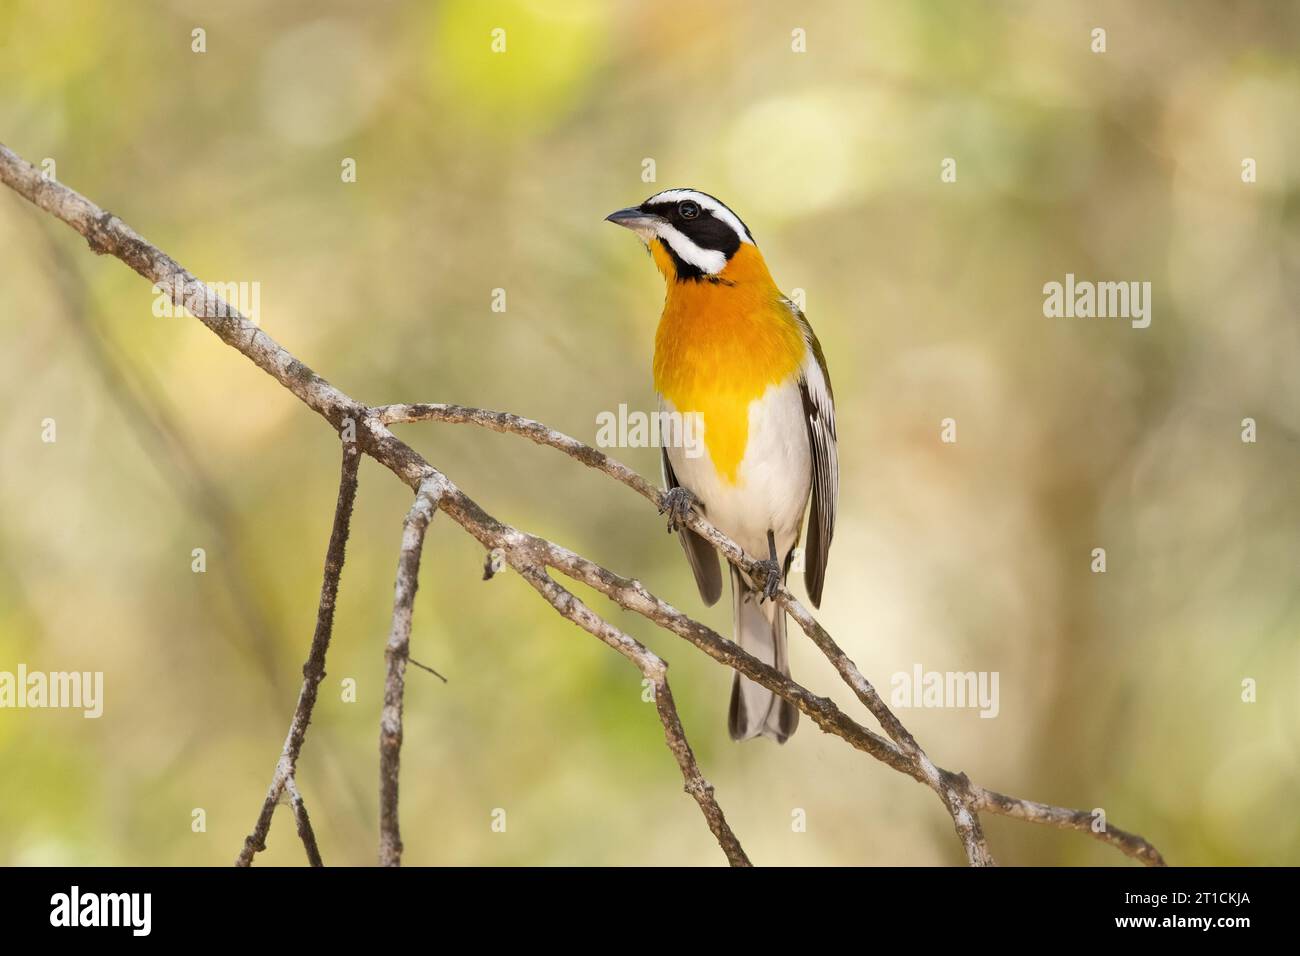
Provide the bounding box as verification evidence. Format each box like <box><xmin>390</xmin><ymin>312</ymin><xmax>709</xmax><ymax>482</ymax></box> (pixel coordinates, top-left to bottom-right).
<box><xmin>0</xmin><ymin>0</ymin><xmax>1300</xmax><ymax>865</ymax></box>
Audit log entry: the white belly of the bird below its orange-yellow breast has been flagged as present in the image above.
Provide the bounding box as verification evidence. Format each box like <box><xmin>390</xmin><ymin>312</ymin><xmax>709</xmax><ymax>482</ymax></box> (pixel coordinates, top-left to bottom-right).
<box><xmin>660</xmin><ymin>381</ymin><xmax>813</xmax><ymax>561</ymax></box>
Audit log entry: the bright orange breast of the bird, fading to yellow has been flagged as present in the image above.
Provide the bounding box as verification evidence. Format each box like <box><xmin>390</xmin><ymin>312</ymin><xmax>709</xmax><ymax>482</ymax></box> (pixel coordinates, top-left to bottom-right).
<box><xmin>651</xmin><ymin>242</ymin><xmax>805</xmax><ymax>484</ymax></box>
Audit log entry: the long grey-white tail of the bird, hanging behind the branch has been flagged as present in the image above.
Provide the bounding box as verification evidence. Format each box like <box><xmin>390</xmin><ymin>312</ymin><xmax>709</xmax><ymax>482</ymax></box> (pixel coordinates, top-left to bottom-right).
<box><xmin>727</xmin><ymin>567</ymin><xmax>800</xmax><ymax>744</ymax></box>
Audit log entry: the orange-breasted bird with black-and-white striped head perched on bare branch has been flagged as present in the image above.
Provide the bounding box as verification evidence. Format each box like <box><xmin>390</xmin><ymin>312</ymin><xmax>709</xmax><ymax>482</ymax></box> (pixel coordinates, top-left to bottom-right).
<box><xmin>606</xmin><ymin>189</ymin><xmax>840</xmax><ymax>743</ymax></box>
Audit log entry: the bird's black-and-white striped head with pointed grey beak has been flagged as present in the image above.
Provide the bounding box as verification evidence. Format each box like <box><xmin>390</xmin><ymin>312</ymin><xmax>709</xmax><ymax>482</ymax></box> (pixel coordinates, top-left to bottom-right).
<box><xmin>606</xmin><ymin>189</ymin><xmax>770</xmax><ymax>289</ymax></box>
